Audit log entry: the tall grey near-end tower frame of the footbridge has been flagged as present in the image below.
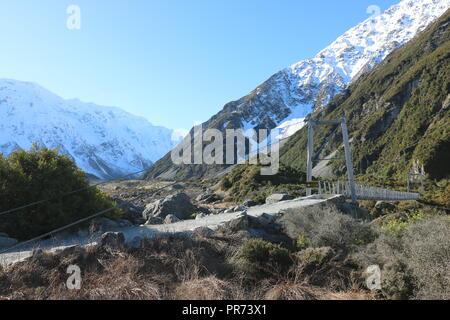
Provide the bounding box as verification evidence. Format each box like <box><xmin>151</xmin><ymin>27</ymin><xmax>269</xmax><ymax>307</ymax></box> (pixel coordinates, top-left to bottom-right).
<box><xmin>306</xmin><ymin>116</ymin><xmax>358</xmax><ymax>204</ymax></box>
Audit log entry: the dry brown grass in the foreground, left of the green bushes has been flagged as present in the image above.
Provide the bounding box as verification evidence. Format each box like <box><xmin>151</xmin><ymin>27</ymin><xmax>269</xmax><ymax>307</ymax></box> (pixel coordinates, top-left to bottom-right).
<box><xmin>0</xmin><ymin>232</ymin><xmax>368</xmax><ymax>300</ymax></box>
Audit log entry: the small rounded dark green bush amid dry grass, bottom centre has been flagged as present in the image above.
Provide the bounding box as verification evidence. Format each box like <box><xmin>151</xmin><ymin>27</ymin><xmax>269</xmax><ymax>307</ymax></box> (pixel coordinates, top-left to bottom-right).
<box><xmin>234</xmin><ymin>239</ymin><xmax>293</xmax><ymax>277</ymax></box>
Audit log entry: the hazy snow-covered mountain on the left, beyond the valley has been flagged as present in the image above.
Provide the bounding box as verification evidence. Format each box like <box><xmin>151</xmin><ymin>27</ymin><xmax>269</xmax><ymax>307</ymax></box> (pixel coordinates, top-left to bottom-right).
<box><xmin>0</xmin><ymin>79</ymin><xmax>179</xmax><ymax>179</ymax></box>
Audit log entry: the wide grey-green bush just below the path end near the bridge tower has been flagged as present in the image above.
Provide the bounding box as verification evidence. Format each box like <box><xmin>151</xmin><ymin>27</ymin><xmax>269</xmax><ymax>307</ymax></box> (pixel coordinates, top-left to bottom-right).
<box><xmin>280</xmin><ymin>204</ymin><xmax>376</xmax><ymax>250</ymax></box>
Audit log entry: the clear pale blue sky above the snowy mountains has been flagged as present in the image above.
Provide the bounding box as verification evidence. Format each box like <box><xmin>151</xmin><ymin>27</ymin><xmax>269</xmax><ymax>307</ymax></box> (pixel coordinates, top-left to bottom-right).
<box><xmin>0</xmin><ymin>0</ymin><xmax>399</xmax><ymax>129</ymax></box>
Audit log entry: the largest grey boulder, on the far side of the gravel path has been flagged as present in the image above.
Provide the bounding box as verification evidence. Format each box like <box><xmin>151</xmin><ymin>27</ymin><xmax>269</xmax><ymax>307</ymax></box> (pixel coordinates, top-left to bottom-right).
<box><xmin>142</xmin><ymin>193</ymin><xmax>198</xmax><ymax>220</ymax></box>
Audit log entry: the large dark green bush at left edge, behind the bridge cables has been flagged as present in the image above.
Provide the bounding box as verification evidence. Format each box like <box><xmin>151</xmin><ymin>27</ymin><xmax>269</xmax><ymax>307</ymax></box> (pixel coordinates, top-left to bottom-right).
<box><xmin>0</xmin><ymin>145</ymin><xmax>121</xmax><ymax>240</ymax></box>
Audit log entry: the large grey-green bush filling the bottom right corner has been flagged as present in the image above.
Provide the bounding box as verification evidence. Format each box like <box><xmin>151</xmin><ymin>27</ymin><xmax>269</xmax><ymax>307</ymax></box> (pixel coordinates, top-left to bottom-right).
<box><xmin>355</xmin><ymin>217</ymin><xmax>450</xmax><ymax>300</ymax></box>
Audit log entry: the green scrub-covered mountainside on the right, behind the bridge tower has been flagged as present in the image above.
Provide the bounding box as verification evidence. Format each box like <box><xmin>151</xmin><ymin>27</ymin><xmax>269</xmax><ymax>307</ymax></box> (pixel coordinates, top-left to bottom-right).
<box><xmin>281</xmin><ymin>10</ymin><xmax>450</xmax><ymax>181</ymax></box>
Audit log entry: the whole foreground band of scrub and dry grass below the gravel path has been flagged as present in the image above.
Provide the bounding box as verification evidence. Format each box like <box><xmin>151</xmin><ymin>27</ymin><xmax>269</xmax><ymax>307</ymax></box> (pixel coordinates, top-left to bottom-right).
<box><xmin>0</xmin><ymin>200</ymin><xmax>450</xmax><ymax>300</ymax></box>
